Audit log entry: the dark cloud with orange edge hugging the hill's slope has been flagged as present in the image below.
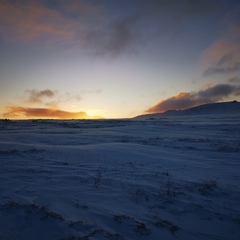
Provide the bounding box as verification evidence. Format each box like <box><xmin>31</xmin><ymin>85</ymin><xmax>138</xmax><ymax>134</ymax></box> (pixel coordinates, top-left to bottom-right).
<box><xmin>146</xmin><ymin>84</ymin><xmax>240</xmax><ymax>113</ymax></box>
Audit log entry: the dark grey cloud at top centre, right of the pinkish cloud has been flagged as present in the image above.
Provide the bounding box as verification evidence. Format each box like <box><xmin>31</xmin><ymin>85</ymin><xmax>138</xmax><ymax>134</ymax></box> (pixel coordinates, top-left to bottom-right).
<box><xmin>87</xmin><ymin>0</ymin><xmax>221</xmax><ymax>56</ymax></box>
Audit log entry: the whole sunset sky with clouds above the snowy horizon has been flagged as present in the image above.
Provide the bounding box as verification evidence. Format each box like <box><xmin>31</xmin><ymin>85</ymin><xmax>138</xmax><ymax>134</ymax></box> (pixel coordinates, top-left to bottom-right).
<box><xmin>0</xmin><ymin>0</ymin><xmax>240</xmax><ymax>119</ymax></box>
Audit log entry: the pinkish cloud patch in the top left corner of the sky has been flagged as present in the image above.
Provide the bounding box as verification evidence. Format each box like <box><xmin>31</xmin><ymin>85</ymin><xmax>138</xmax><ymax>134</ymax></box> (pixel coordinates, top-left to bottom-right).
<box><xmin>0</xmin><ymin>0</ymin><xmax>77</xmax><ymax>43</ymax></box>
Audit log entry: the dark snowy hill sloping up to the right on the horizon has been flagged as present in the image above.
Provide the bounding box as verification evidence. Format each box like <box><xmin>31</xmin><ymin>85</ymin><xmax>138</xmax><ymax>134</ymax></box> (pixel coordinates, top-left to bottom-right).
<box><xmin>135</xmin><ymin>101</ymin><xmax>240</xmax><ymax>118</ymax></box>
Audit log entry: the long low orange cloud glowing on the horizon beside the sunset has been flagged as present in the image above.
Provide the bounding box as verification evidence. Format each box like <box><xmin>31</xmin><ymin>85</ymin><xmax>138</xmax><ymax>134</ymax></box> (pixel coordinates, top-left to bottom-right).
<box><xmin>2</xmin><ymin>105</ymin><xmax>100</xmax><ymax>119</ymax></box>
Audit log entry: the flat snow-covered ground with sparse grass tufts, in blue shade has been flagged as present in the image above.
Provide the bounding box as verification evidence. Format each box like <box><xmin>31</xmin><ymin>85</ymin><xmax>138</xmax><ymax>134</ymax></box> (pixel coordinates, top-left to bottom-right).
<box><xmin>0</xmin><ymin>114</ymin><xmax>240</xmax><ymax>240</ymax></box>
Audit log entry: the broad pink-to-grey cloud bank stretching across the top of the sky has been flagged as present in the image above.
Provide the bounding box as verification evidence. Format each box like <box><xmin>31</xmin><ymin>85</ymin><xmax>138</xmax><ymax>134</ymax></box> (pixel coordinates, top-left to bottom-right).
<box><xmin>0</xmin><ymin>0</ymin><xmax>229</xmax><ymax>56</ymax></box>
